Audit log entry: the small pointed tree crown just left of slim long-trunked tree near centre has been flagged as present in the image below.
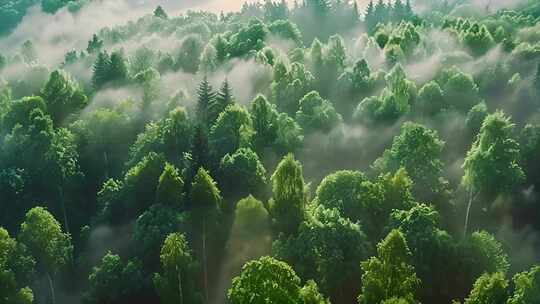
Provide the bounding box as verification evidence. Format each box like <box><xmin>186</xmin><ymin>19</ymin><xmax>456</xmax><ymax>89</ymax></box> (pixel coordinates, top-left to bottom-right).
<box><xmin>156</xmin><ymin>163</ymin><xmax>184</xmax><ymax>208</ymax></box>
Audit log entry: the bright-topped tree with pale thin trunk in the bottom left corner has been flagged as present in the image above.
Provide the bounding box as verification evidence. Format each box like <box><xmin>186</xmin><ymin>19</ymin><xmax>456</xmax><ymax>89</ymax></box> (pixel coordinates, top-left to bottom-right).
<box><xmin>19</xmin><ymin>207</ymin><xmax>73</xmax><ymax>304</ymax></box>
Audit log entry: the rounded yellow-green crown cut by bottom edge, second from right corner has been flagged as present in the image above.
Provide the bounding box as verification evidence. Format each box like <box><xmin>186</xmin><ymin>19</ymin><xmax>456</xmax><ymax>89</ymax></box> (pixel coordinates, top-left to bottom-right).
<box><xmin>465</xmin><ymin>272</ymin><xmax>508</xmax><ymax>304</ymax></box>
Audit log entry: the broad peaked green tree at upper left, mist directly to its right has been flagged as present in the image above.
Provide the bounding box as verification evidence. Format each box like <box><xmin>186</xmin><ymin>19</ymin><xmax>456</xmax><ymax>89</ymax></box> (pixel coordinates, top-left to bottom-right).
<box><xmin>40</xmin><ymin>70</ymin><xmax>88</xmax><ymax>125</ymax></box>
